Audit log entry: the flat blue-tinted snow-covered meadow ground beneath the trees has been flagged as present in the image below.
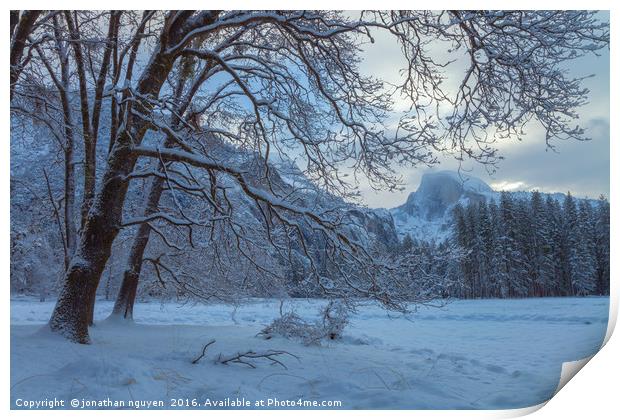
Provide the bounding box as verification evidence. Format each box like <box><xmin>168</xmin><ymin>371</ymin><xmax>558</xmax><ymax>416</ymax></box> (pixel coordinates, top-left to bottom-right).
<box><xmin>11</xmin><ymin>298</ymin><xmax>609</xmax><ymax>409</ymax></box>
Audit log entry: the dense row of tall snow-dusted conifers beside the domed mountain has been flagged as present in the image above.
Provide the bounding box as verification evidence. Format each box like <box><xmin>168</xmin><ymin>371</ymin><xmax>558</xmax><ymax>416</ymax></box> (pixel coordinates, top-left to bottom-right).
<box><xmin>402</xmin><ymin>191</ymin><xmax>610</xmax><ymax>298</ymax></box>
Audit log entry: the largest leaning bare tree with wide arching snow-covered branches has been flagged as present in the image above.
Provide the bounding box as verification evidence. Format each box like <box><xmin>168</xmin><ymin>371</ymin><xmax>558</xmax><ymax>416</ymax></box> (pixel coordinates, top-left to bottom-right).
<box><xmin>8</xmin><ymin>11</ymin><xmax>608</xmax><ymax>343</ymax></box>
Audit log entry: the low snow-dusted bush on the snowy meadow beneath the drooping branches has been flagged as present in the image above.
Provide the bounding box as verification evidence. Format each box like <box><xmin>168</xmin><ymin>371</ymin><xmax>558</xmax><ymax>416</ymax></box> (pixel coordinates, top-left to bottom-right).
<box><xmin>259</xmin><ymin>301</ymin><xmax>349</xmax><ymax>345</ymax></box>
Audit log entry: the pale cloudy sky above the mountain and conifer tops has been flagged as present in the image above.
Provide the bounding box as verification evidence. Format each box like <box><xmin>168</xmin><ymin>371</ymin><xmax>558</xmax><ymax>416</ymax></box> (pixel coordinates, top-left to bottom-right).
<box><xmin>354</xmin><ymin>13</ymin><xmax>610</xmax><ymax>208</ymax></box>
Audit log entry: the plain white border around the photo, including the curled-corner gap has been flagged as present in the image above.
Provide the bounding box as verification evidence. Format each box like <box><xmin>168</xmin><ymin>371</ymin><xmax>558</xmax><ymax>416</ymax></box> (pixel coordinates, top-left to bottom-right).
<box><xmin>0</xmin><ymin>0</ymin><xmax>620</xmax><ymax>420</ymax></box>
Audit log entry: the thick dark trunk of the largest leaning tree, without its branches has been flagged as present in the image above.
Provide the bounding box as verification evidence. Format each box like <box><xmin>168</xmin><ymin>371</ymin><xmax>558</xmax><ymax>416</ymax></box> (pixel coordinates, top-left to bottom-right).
<box><xmin>50</xmin><ymin>12</ymin><xmax>225</xmax><ymax>343</ymax></box>
